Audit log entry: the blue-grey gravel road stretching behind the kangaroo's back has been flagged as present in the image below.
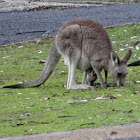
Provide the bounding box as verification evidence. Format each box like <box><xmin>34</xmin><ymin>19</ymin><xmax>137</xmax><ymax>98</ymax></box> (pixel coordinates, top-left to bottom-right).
<box><xmin>0</xmin><ymin>4</ymin><xmax>140</xmax><ymax>45</ymax></box>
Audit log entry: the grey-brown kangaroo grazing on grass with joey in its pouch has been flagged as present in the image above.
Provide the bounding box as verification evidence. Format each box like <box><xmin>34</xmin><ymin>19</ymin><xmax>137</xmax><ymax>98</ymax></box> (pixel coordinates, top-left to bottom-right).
<box><xmin>4</xmin><ymin>19</ymin><xmax>132</xmax><ymax>89</ymax></box>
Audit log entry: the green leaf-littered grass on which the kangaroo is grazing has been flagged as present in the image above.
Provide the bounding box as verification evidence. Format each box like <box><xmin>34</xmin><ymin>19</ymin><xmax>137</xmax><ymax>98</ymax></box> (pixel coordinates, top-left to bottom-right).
<box><xmin>0</xmin><ymin>24</ymin><xmax>140</xmax><ymax>137</ymax></box>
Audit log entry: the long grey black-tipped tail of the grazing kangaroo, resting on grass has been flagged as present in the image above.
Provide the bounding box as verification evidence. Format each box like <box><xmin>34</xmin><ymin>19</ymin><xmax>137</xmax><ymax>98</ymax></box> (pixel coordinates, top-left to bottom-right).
<box><xmin>3</xmin><ymin>41</ymin><xmax>61</xmax><ymax>88</ymax></box>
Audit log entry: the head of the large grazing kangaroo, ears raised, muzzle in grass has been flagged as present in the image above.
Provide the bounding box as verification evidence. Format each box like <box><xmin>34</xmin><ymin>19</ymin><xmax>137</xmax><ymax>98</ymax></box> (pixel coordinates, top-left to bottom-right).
<box><xmin>111</xmin><ymin>50</ymin><xmax>132</xmax><ymax>86</ymax></box>
